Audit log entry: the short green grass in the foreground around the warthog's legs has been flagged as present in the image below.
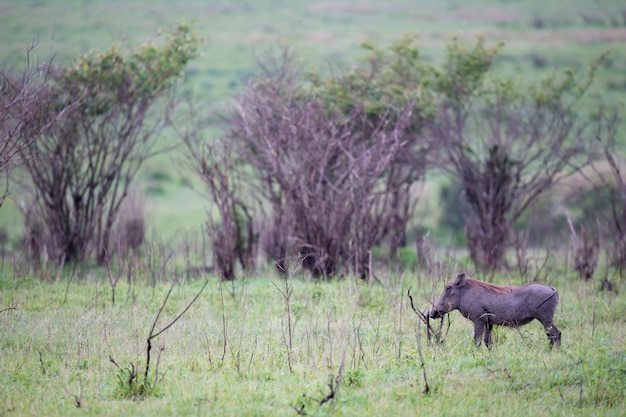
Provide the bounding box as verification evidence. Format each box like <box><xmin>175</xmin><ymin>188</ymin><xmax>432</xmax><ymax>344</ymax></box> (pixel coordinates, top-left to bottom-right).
<box><xmin>0</xmin><ymin>262</ymin><xmax>626</xmax><ymax>416</ymax></box>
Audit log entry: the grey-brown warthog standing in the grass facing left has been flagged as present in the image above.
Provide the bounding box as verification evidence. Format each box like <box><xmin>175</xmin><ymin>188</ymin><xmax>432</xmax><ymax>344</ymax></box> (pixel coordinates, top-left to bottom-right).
<box><xmin>429</xmin><ymin>274</ymin><xmax>561</xmax><ymax>347</ymax></box>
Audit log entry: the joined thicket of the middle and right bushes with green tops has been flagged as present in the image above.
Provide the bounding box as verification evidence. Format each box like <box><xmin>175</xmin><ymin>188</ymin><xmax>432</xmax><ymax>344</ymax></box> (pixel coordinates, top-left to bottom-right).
<box><xmin>188</xmin><ymin>37</ymin><xmax>607</xmax><ymax>276</ymax></box>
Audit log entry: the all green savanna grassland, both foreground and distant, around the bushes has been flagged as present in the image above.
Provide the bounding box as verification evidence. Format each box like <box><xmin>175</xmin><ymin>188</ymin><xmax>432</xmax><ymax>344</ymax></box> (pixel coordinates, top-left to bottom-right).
<box><xmin>0</xmin><ymin>0</ymin><xmax>626</xmax><ymax>416</ymax></box>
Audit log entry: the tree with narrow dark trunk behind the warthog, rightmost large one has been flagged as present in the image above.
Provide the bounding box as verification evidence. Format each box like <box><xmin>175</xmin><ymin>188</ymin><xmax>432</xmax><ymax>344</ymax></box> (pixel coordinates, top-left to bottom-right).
<box><xmin>429</xmin><ymin>42</ymin><xmax>598</xmax><ymax>271</ymax></box>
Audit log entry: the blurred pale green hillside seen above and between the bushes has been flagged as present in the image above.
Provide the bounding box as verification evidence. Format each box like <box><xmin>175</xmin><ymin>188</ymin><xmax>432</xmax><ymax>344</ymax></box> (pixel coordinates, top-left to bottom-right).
<box><xmin>0</xmin><ymin>0</ymin><xmax>626</xmax><ymax>264</ymax></box>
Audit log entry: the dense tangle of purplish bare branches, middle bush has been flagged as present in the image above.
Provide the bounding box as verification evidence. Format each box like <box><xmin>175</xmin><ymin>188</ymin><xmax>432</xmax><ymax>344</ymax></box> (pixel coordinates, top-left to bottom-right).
<box><xmin>223</xmin><ymin>54</ymin><xmax>424</xmax><ymax>277</ymax></box>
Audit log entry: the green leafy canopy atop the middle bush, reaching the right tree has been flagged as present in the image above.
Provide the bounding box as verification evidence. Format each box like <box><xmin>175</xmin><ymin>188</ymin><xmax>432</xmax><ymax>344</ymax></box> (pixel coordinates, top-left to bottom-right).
<box><xmin>310</xmin><ymin>34</ymin><xmax>504</xmax><ymax>130</ymax></box>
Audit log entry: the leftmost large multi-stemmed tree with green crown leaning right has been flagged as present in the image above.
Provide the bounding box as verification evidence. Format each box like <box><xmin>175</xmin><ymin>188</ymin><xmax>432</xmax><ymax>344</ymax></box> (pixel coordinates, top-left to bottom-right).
<box><xmin>19</xmin><ymin>25</ymin><xmax>198</xmax><ymax>262</ymax></box>
